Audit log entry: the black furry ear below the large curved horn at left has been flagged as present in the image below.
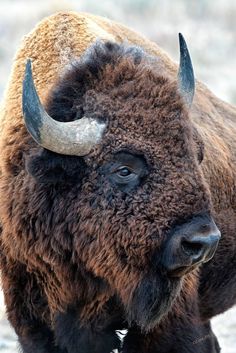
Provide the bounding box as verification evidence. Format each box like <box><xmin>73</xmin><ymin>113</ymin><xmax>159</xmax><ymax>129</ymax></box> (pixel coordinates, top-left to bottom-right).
<box><xmin>26</xmin><ymin>149</ymin><xmax>87</xmax><ymax>185</ymax></box>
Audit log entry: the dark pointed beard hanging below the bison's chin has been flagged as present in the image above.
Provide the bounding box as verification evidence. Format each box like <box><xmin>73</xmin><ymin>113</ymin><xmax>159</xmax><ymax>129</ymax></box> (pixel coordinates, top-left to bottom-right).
<box><xmin>127</xmin><ymin>273</ymin><xmax>182</xmax><ymax>332</ymax></box>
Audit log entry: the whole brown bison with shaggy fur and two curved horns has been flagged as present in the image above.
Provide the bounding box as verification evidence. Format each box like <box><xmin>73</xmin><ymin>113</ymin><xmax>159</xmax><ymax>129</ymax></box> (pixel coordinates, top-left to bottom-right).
<box><xmin>0</xmin><ymin>13</ymin><xmax>236</xmax><ymax>353</ymax></box>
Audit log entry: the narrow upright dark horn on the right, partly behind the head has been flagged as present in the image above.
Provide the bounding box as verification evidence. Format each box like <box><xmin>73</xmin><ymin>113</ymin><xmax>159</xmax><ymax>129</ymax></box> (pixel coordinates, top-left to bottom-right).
<box><xmin>178</xmin><ymin>33</ymin><xmax>195</xmax><ymax>108</ymax></box>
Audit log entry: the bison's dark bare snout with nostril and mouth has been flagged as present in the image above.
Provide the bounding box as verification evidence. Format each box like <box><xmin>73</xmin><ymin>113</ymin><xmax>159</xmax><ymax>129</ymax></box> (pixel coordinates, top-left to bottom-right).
<box><xmin>162</xmin><ymin>215</ymin><xmax>220</xmax><ymax>277</ymax></box>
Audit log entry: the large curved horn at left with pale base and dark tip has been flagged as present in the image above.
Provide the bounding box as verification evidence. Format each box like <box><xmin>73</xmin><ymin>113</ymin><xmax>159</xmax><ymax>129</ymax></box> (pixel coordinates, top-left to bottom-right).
<box><xmin>22</xmin><ymin>60</ymin><xmax>106</xmax><ymax>156</ymax></box>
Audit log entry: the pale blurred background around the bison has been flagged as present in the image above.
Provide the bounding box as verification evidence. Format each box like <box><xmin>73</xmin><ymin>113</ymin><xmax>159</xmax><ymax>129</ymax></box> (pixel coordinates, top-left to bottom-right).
<box><xmin>0</xmin><ymin>0</ymin><xmax>236</xmax><ymax>353</ymax></box>
